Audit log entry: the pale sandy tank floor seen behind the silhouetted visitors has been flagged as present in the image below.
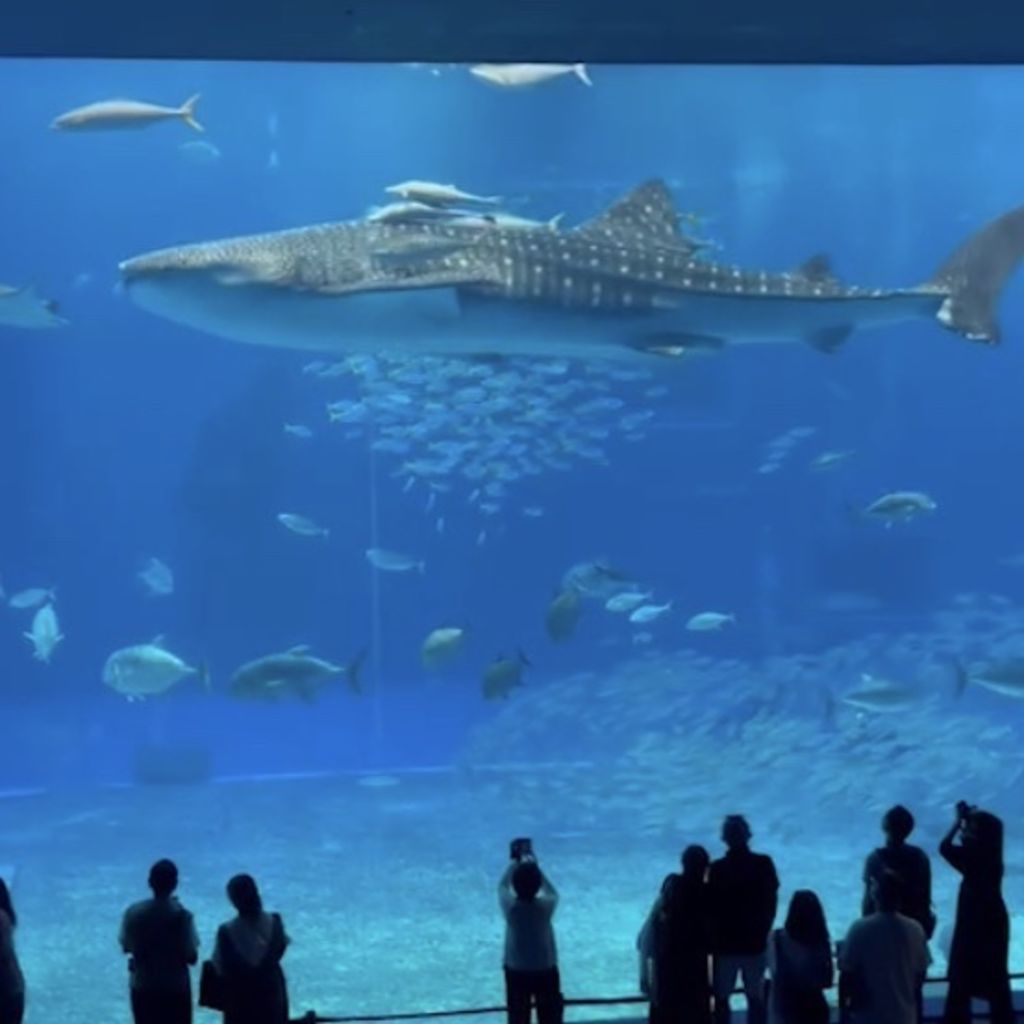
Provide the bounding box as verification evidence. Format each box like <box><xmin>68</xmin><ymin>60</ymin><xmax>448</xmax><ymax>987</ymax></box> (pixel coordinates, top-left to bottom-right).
<box><xmin>0</xmin><ymin>775</ymin><xmax>1024</xmax><ymax>1024</ymax></box>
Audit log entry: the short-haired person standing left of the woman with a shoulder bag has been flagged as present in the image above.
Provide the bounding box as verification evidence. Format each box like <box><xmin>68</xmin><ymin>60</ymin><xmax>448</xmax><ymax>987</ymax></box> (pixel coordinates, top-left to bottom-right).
<box><xmin>120</xmin><ymin>860</ymin><xmax>199</xmax><ymax>1024</ymax></box>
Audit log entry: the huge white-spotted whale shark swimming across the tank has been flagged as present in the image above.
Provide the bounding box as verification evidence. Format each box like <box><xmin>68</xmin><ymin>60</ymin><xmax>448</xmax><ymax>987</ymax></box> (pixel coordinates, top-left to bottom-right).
<box><xmin>121</xmin><ymin>180</ymin><xmax>1024</xmax><ymax>358</ymax></box>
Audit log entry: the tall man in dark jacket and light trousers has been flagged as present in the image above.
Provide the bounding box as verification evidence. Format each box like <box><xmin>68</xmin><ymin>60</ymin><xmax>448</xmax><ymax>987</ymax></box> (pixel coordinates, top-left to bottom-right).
<box><xmin>708</xmin><ymin>814</ymin><xmax>778</xmax><ymax>1024</ymax></box>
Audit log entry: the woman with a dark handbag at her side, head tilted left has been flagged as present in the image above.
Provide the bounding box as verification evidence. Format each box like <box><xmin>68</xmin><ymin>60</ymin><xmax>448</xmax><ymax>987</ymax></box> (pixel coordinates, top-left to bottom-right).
<box><xmin>212</xmin><ymin>874</ymin><xmax>289</xmax><ymax>1024</ymax></box>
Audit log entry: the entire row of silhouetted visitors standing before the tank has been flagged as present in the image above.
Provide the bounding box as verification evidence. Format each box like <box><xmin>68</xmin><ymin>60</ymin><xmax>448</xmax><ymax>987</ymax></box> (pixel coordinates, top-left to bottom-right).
<box><xmin>0</xmin><ymin>803</ymin><xmax>1014</xmax><ymax>1024</ymax></box>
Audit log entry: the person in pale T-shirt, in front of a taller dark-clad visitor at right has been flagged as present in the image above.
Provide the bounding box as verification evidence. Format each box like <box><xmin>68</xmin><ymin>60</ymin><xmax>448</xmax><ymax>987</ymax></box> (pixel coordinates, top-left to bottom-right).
<box><xmin>839</xmin><ymin>871</ymin><xmax>931</xmax><ymax>1024</ymax></box>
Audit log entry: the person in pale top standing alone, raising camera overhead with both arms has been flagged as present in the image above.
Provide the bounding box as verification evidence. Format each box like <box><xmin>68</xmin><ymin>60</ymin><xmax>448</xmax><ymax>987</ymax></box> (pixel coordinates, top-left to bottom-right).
<box><xmin>498</xmin><ymin>839</ymin><xmax>562</xmax><ymax>1024</ymax></box>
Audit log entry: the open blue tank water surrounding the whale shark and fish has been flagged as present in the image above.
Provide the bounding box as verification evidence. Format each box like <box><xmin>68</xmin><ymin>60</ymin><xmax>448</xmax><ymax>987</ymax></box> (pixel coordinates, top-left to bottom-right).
<box><xmin>0</xmin><ymin>61</ymin><xmax>1024</xmax><ymax>1009</ymax></box>
